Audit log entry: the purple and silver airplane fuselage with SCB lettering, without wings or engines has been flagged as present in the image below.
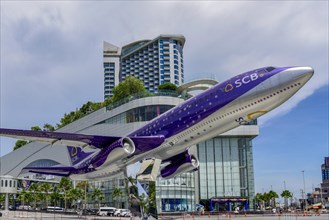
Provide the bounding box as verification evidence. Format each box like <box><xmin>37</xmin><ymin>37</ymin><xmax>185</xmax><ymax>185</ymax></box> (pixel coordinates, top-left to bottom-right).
<box><xmin>72</xmin><ymin>67</ymin><xmax>313</xmax><ymax>178</ymax></box>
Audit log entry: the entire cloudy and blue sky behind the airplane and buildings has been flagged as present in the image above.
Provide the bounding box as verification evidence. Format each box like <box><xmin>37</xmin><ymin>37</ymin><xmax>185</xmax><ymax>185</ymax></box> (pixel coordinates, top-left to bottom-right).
<box><xmin>0</xmin><ymin>1</ymin><xmax>329</xmax><ymax>195</ymax></box>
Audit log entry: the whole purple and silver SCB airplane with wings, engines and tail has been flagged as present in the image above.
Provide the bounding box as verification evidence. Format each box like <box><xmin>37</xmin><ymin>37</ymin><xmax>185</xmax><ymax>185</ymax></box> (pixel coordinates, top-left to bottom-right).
<box><xmin>0</xmin><ymin>67</ymin><xmax>314</xmax><ymax>179</ymax></box>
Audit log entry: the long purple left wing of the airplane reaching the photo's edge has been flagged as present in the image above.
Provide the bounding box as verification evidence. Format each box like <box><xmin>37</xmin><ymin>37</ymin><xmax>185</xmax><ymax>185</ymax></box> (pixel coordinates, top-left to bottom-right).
<box><xmin>0</xmin><ymin>128</ymin><xmax>121</xmax><ymax>148</ymax></box>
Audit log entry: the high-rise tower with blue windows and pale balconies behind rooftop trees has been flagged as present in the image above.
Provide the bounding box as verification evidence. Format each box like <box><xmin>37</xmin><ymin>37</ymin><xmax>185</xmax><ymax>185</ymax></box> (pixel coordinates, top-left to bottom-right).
<box><xmin>103</xmin><ymin>35</ymin><xmax>185</xmax><ymax>98</ymax></box>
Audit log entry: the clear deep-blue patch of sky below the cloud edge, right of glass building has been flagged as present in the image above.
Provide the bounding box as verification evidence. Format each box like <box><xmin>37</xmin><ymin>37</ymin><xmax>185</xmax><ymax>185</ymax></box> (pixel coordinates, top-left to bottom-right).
<box><xmin>253</xmin><ymin>86</ymin><xmax>329</xmax><ymax>198</ymax></box>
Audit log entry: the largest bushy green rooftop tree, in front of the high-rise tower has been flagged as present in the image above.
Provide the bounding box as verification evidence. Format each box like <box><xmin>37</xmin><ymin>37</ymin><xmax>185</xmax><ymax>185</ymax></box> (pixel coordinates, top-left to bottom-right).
<box><xmin>112</xmin><ymin>76</ymin><xmax>146</xmax><ymax>102</ymax></box>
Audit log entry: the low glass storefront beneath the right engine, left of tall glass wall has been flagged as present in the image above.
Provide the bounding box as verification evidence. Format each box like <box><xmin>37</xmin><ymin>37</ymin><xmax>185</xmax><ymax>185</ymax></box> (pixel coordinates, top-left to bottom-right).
<box><xmin>156</xmin><ymin>173</ymin><xmax>195</xmax><ymax>213</ymax></box>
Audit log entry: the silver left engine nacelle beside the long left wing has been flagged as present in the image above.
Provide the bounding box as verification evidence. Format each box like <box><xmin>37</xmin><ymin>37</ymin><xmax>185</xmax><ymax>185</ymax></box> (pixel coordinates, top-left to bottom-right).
<box><xmin>106</xmin><ymin>137</ymin><xmax>136</xmax><ymax>164</ymax></box>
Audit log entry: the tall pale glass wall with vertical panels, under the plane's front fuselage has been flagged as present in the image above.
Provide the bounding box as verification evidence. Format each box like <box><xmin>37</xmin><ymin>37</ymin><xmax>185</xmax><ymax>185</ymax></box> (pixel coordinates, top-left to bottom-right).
<box><xmin>197</xmin><ymin>137</ymin><xmax>254</xmax><ymax>211</ymax></box>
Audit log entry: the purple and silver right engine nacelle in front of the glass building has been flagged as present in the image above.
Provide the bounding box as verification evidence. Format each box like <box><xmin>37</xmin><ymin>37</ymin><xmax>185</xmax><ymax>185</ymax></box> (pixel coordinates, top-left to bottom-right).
<box><xmin>161</xmin><ymin>151</ymin><xmax>199</xmax><ymax>179</ymax></box>
